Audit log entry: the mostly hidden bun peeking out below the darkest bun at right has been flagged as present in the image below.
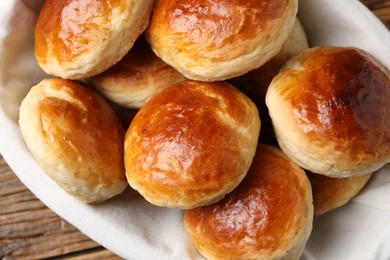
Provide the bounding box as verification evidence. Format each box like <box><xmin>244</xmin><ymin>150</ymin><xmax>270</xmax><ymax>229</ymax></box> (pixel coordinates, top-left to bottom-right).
<box><xmin>307</xmin><ymin>172</ymin><xmax>372</xmax><ymax>215</ymax></box>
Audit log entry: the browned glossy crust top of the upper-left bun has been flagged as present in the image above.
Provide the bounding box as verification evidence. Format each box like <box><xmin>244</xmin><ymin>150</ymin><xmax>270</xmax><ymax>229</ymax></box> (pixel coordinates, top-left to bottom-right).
<box><xmin>35</xmin><ymin>0</ymin><xmax>126</xmax><ymax>61</ymax></box>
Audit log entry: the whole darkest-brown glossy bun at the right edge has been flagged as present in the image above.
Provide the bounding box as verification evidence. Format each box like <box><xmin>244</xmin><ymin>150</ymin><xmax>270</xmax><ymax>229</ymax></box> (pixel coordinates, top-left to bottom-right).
<box><xmin>266</xmin><ymin>46</ymin><xmax>390</xmax><ymax>178</ymax></box>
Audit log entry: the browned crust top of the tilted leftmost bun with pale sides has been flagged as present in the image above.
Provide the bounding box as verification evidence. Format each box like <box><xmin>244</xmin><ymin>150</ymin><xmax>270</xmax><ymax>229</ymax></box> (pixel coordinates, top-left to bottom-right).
<box><xmin>38</xmin><ymin>78</ymin><xmax>124</xmax><ymax>181</ymax></box>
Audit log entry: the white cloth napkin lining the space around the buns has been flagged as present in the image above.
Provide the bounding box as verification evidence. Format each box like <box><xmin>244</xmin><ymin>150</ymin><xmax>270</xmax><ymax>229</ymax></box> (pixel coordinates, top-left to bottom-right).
<box><xmin>0</xmin><ymin>0</ymin><xmax>390</xmax><ymax>260</ymax></box>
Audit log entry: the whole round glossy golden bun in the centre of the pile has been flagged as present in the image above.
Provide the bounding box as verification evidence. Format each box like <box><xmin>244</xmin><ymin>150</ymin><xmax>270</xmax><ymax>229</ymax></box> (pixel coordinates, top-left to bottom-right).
<box><xmin>125</xmin><ymin>81</ymin><xmax>260</xmax><ymax>209</ymax></box>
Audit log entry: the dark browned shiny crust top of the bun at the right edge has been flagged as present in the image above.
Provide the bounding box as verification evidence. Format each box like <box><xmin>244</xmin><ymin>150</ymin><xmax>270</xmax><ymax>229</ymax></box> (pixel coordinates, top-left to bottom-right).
<box><xmin>282</xmin><ymin>47</ymin><xmax>390</xmax><ymax>152</ymax></box>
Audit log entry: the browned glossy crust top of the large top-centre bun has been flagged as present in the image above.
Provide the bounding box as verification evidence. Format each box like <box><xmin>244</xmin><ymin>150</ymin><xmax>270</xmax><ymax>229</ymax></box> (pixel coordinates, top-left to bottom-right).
<box><xmin>152</xmin><ymin>0</ymin><xmax>290</xmax><ymax>59</ymax></box>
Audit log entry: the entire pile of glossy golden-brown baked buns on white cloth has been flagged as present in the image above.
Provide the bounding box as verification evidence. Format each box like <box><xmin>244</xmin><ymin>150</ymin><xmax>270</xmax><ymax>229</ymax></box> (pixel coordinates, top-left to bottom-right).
<box><xmin>19</xmin><ymin>0</ymin><xmax>390</xmax><ymax>259</ymax></box>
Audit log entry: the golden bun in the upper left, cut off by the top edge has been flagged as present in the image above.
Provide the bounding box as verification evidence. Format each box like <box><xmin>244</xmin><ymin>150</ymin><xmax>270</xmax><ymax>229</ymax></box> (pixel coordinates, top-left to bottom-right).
<box><xmin>35</xmin><ymin>0</ymin><xmax>154</xmax><ymax>79</ymax></box>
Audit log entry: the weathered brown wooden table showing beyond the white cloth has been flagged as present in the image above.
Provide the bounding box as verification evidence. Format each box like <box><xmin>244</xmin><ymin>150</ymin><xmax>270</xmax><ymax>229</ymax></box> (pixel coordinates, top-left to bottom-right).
<box><xmin>0</xmin><ymin>0</ymin><xmax>390</xmax><ymax>260</ymax></box>
